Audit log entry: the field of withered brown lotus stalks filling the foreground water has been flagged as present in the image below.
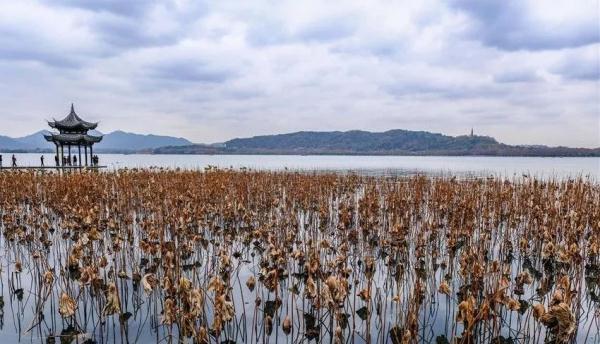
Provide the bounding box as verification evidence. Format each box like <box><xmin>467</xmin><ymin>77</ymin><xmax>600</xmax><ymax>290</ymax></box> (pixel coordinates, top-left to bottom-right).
<box><xmin>0</xmin><ymin>169</ymin><xmax>600</xmax><ymax>343</ymax></box>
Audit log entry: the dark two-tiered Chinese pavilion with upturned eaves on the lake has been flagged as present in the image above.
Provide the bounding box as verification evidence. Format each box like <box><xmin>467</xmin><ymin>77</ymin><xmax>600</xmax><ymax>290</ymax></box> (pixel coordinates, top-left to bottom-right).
<box><xmin>44</xmin><ymin>104</ymin><xmax>102</xmax><ymax>166</ymax></box>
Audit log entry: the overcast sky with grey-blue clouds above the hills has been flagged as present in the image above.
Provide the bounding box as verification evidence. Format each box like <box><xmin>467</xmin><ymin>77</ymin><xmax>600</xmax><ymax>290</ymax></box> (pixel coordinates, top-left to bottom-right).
<box><xmin>0</xmin><ymin>0</ymin><xmax>600</xmax><ymax>147</ymax></box>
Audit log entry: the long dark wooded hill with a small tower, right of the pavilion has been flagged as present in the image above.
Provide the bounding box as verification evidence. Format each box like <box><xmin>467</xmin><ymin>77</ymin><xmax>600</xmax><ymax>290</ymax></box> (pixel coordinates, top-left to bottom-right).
<box><xmin>153</xmin><ymin>130</ymin><xmax>600</xmax><ymax>156</ymax></box>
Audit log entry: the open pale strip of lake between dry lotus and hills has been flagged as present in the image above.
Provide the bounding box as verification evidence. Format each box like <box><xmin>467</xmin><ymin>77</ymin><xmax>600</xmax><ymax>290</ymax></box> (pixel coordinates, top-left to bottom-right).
<box><xmin>2</xmin><ymin>153</ymin><xmax>600</xmax><ymax>180</ymax></box>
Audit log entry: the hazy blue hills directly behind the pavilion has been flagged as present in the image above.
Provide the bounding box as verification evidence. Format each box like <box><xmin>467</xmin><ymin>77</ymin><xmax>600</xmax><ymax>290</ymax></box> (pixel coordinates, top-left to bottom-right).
<box><xmin>0</xmin><ymin>130</ymin><xmax>193</xmax><ymax>153</ymax></box>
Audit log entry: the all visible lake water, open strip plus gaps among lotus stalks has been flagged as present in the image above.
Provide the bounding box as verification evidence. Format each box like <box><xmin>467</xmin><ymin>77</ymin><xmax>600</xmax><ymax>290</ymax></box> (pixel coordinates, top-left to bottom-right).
<box><xmin>0</xmin><ymin>154</ymin><xmax>600</xmax><ymax>343</ymax></box>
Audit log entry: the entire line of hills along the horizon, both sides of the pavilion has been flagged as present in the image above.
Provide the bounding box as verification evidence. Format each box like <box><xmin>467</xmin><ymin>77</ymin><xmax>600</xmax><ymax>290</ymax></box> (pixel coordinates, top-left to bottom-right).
<box><xmin>0</xmin><ymin>129</ymin><xmax>600</xmax><ymax>157</ymax></box>
